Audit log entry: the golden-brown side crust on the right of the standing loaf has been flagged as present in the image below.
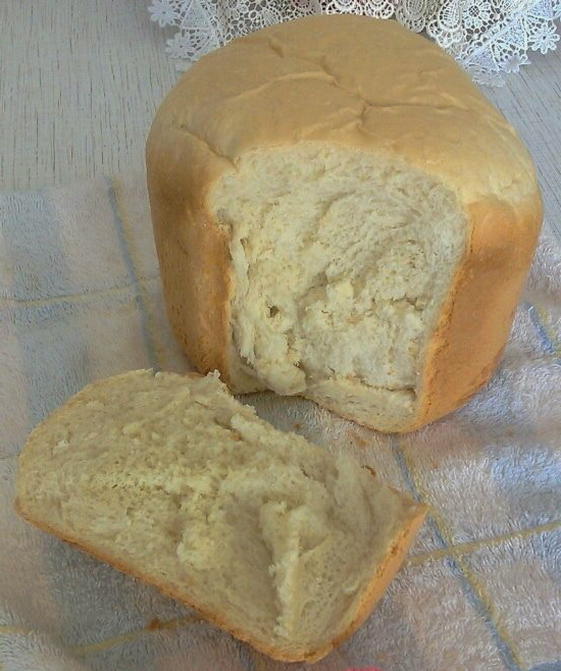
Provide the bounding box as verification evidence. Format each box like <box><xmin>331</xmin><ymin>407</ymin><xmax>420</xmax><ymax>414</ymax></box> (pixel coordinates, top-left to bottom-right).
<box><xmin>404</xmin><ymin>193</ymin><xmax>542</xmax><ymax>430</ymax></box>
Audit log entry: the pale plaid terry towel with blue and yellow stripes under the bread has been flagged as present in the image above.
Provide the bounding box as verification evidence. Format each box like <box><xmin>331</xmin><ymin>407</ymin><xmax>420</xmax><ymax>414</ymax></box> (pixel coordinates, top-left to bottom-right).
<box><xmin>0</xmin><ymin>173</ymin><xmax>561</xmax><ymax>671</ymax></box>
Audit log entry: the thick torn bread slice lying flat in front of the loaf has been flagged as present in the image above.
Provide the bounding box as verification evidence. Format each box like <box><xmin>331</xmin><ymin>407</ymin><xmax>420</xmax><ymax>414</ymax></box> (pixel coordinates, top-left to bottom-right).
<box><xmin>16</xmin><ymin>371</ymin><xmax>425</xmax><ymax>661</ymax></box>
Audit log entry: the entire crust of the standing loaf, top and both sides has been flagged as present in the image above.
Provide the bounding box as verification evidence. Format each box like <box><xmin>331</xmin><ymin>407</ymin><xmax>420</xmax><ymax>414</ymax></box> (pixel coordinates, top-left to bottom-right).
<box><xmin>147</xmin><ymin>15</ymin><xmax>542</xmax><ymax>431</ymax></box>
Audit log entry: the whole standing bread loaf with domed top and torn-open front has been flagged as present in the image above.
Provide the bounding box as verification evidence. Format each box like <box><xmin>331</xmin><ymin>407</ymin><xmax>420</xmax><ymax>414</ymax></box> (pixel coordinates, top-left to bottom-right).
<box><xmin>147</xmin><ymin>15</ymin><xmax>542</xmax><ymax>431</ymax></box>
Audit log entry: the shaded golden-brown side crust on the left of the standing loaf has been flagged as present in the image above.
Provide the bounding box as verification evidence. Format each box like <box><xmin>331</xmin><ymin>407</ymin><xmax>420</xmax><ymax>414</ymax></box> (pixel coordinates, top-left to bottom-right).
<box><xmin>147</xmin><ymin>131</ymin><xmax>230</xmax><ymax>382</ymax></box>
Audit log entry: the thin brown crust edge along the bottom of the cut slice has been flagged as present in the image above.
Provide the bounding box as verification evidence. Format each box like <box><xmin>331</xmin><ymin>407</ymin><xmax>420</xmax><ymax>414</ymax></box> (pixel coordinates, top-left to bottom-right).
<box><xmin>14</xmin><ymin>469</ymin><xmax>426</xmax><ymax>662</ymax></box>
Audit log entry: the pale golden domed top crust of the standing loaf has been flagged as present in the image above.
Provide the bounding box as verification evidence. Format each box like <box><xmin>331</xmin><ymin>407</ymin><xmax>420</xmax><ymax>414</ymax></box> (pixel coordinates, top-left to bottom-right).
<box><xmin>148</xmin><ymin>15</ymin><xmax>535</xmax><ymax>203</ymax></box>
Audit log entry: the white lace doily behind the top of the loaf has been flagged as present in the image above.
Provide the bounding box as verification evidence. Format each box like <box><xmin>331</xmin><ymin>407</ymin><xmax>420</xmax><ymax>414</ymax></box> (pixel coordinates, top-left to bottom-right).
<box><xmin>148</xmin><ymin>0</ymin><xmax>561</xmax><ymax>85</ymax></box>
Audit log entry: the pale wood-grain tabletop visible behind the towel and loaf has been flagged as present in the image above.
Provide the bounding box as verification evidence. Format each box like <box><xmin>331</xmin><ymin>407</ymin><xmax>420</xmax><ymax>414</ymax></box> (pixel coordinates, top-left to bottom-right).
<box><xmin>0</xmin><ymin>0</ymin><xmax>561</xmax><ymax>201</ymax></box>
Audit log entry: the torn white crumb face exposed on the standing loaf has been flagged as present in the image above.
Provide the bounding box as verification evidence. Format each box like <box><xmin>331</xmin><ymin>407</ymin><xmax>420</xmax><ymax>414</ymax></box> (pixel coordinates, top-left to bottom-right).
<box><xmin>210</xmin><ymin>143</ymin><xmax>467</xmax><ymax>429</ymax></box>
